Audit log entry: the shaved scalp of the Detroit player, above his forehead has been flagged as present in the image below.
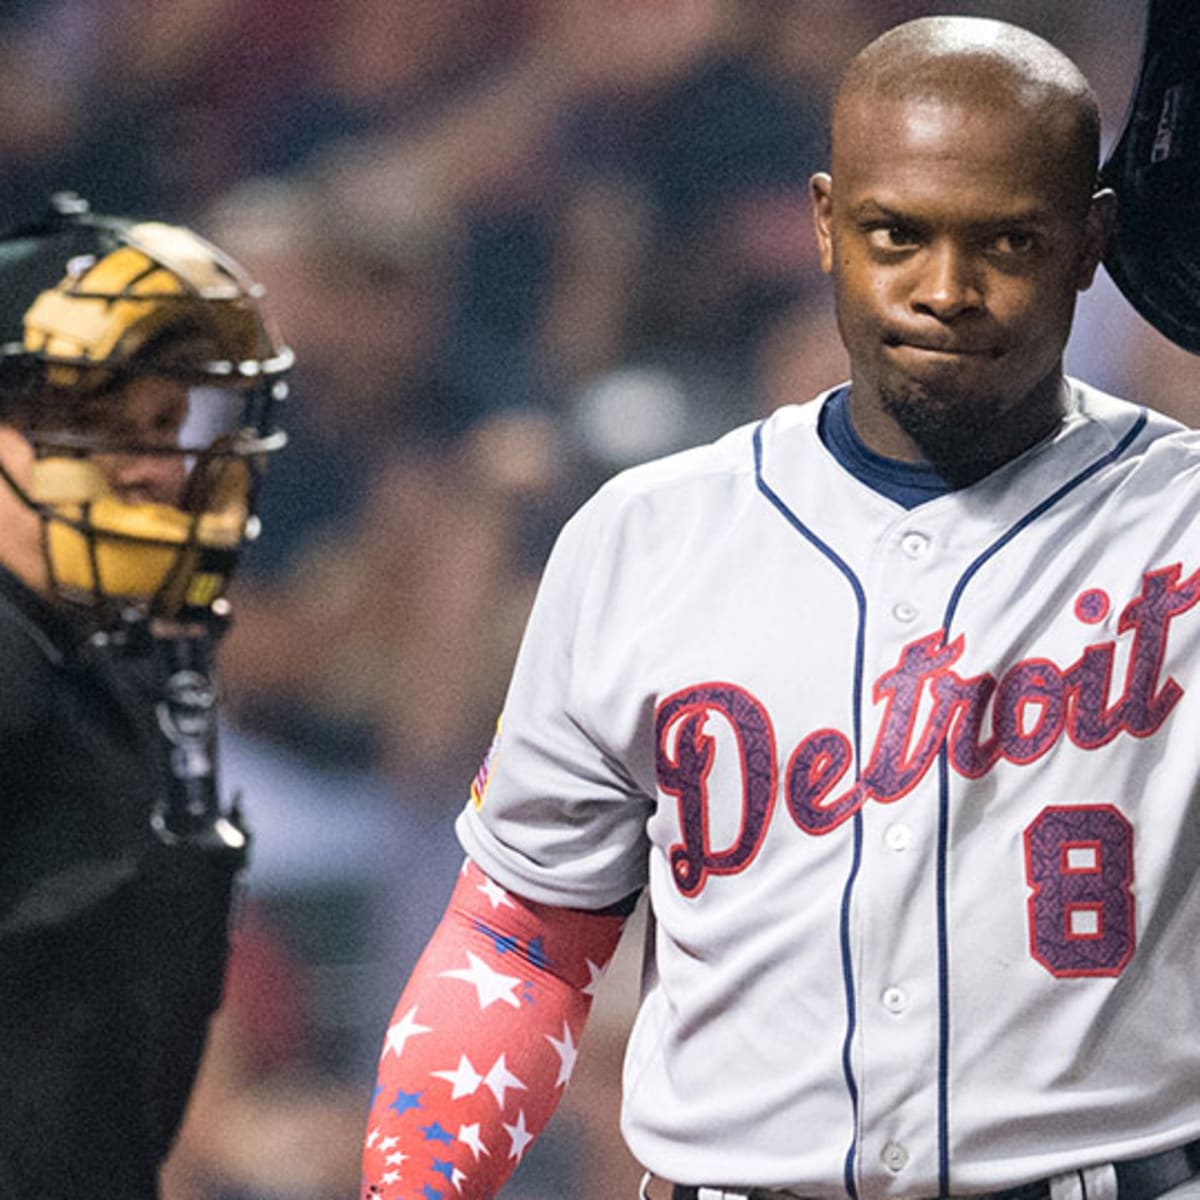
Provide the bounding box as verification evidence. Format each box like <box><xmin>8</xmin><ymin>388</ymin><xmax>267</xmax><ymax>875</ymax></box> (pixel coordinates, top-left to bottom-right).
<box><xmin>832</xmin><ymin>17</ymin><xmax>1100</xmax><ymax>204</ymax></box>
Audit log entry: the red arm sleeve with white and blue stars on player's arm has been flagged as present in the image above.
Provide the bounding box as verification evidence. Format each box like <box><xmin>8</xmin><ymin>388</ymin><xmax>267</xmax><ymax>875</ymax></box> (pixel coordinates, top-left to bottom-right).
<box><xmin>362</xmin><ymin>862</ymin><xmax>625</xmax><ymax>1200</ymax></box>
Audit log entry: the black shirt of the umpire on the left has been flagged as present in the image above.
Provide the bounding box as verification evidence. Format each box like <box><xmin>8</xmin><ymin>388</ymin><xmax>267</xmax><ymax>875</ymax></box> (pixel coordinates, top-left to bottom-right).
<box><xmin>0</xmin><ymin>568</ymin><xmax>241</xmax><ymax>1200</ymax></box>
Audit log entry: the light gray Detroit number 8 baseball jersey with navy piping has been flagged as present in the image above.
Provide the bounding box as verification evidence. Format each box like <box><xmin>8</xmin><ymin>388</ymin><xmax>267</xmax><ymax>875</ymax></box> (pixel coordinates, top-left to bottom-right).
<box><xmin>458</xmin><ymin>382</ymin><xmax>1200</xmax><ymax>1198</ymax></box>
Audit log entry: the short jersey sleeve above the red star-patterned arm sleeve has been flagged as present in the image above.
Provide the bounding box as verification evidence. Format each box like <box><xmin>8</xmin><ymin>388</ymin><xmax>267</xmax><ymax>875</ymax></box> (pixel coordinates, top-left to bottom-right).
<box><xmin>457</xmin><ymin>487</ymin><xmax>654</xmax><ymax>908</ymax></box>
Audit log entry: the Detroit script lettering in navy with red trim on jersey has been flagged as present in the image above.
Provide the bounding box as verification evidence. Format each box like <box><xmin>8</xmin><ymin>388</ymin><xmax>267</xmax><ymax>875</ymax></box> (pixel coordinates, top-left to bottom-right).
<box><xmin>655</xmin><ymin>563</ymin><xmax>1200</xmax><ymax>895</ymax></box>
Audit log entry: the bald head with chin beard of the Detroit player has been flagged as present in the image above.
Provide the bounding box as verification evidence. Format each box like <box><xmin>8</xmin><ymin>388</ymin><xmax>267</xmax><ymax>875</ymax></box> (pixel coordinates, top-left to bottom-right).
<box><xmin>812</xmin><ymin>18</ymin><xmax>1112</xmax><ymax>484</ymax></box>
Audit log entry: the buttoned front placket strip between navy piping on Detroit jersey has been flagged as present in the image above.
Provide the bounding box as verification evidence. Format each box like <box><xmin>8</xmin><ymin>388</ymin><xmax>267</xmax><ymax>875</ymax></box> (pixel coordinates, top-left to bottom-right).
<box><xmin>851</xmin><ymin>510</ymin><xmax>948</xmax><ymax>1198</ymax></box>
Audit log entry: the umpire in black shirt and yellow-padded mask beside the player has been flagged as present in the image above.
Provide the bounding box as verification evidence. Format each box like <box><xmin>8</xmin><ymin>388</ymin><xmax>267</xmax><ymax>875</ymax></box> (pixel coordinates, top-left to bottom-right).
<box><xmin>0</xmin><ymin>194</ymin><xmax>292</xmax><ymax>1200</ymax></box>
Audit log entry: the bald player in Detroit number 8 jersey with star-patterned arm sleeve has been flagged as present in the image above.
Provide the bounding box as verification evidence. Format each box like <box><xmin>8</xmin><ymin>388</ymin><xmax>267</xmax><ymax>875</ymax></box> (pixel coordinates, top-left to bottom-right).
<box><xmin>364</xmin><ymin>18</ymin><xmax>1200</xmax><ymax>1200</ymax></box>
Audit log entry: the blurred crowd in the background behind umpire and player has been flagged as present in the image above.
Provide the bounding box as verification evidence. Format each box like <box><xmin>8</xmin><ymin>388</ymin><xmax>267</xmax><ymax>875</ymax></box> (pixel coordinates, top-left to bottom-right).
<box><xmin>0</xmin><ymin>0</ymin><xmax>1200</xmax><ymax>1200</ymax></box>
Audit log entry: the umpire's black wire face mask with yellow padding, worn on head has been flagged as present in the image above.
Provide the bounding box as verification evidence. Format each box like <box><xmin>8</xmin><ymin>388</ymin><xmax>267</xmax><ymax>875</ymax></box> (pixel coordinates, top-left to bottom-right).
<box><xmin>0</xmin><ymin>194</ymin><xmax>292</xmax><ymax>618</ymax></box>
